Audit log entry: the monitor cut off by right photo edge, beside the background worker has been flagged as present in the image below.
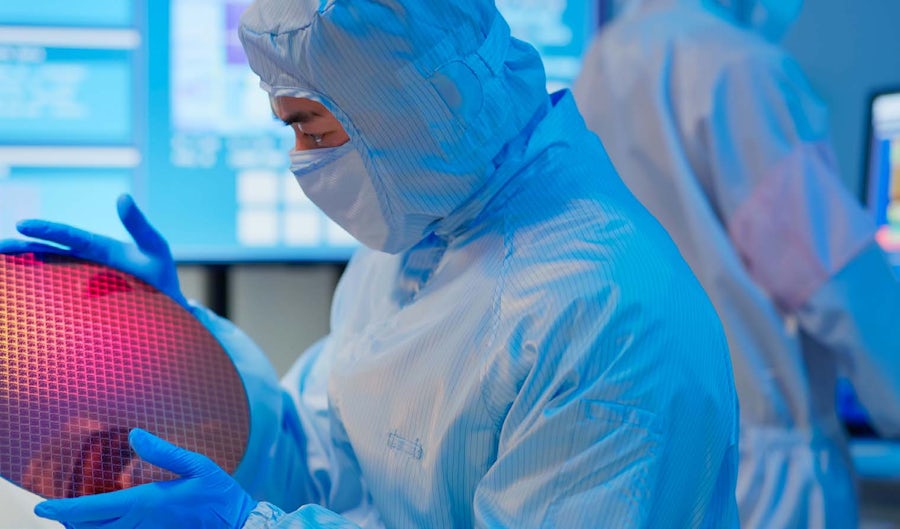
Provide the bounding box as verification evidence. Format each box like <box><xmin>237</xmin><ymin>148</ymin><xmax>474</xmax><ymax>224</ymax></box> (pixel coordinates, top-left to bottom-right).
<box><xmin>863</xmin><ymin>89</ymin><xmax>900</xmax><ymax>266</ymax></box>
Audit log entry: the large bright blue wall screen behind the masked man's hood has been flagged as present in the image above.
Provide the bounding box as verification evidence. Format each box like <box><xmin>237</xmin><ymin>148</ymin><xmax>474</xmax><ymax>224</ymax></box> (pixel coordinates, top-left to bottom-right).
<box><xmin>0</xmin><ymin>0</ymin><xmax>599</xmax><ymax>263</ymax></box>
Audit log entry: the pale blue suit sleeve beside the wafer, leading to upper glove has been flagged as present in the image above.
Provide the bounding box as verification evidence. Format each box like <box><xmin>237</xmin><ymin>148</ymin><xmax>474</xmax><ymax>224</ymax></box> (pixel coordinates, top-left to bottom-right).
<box><xmin>193</xmin><ymin>306</ymin><xmax>378</xmax><ymax>527</ymax></box>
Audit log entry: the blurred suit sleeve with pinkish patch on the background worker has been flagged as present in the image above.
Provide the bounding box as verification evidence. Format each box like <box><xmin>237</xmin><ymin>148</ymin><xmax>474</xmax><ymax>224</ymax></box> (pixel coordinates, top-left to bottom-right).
<box><xmin>710</xmin><ymin>56</ymin><xmax>900</xmax><ymax>436</ymax></box>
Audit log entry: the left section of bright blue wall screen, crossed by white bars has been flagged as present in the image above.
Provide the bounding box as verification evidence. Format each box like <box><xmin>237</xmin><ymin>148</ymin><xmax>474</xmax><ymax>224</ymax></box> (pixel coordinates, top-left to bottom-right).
<box><xmin>0</xmin><ymin>0</ymin><xmax>141</xmax><ymax>245</ymax></box>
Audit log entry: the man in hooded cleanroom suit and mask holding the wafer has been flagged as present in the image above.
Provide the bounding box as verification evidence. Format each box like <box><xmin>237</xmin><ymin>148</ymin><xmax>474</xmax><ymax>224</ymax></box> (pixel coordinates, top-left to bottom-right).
<box><xmin>7</xmin><ymin>0</ymin><xmax>738</xmax><ymax>529</ymax></box>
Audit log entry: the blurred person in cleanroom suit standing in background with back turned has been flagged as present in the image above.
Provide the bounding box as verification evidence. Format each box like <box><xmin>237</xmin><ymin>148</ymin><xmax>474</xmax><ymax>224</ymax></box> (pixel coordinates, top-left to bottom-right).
<box><xmin>574</xmin><ymin>0</ymin><xmax>900</xmax><ymax>529</ymax></box>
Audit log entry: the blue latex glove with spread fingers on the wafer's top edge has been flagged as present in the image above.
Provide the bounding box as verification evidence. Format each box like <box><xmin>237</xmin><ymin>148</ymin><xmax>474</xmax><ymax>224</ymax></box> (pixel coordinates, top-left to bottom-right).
<box><xmin>0</xmin><ymin>195</ymin><xmax>190</xmax><ymax>309</ymax></box>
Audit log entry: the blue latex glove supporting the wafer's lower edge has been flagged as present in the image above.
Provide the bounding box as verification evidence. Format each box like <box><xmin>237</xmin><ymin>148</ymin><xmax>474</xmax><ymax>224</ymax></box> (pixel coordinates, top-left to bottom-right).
<box><xmin>34</xmin><ymin>429</ymin><xmax>257</xmax><ymax>529</ymax></box>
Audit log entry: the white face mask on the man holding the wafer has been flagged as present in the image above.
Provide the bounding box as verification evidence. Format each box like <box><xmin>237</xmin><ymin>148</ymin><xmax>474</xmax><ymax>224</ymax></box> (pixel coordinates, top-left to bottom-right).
<box><xmin>291</xmin><ymin>142</ymin><xmax>400</xmax><ymax>252</ymax></box>
